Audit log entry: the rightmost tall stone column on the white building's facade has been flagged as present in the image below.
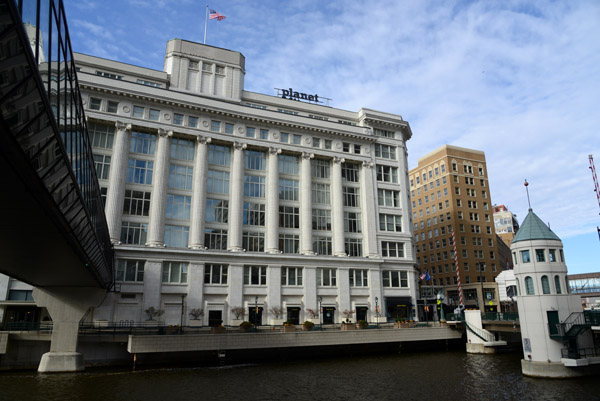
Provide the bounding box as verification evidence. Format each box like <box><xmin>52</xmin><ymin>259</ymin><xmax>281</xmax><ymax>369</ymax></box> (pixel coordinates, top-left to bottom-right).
<box><xmin>360</xmin><ymin>161</ymin><xmax>379</xmax><ymax>257</ymax></box>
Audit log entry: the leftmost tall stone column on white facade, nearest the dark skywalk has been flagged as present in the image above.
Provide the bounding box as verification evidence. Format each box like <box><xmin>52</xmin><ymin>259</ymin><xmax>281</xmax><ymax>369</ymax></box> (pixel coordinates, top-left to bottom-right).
<box><xmin>105</xmin><ymin>121</ymin><xmax>131</xmax><ymax>244</ymax></box>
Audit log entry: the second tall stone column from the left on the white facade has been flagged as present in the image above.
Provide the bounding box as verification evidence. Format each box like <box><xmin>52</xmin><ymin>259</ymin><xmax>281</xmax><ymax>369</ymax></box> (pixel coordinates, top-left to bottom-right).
<box><xmin>146</xmin><ymin>128</ymin><xmax>173</xmax><ymax>247</ymax></box>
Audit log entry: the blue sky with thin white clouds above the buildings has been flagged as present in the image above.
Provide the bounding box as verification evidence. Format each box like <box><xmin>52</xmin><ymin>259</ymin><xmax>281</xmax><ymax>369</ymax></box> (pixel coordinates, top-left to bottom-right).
<box><xmin>65</xmin><ymin>0</ymin><xmax>600</xmax><ymax>273</ymax></box>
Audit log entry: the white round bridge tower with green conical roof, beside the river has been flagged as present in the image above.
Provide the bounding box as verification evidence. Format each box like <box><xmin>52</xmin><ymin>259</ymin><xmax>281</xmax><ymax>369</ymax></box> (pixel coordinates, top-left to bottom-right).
<box><xmin>510</xmin><ymin>209</ymin><xmax>593</xmax><ymax>377</ymax></box>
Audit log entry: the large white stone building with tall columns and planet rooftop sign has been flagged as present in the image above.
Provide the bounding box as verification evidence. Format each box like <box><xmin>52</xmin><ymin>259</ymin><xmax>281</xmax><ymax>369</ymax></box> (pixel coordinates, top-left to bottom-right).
<box><xmin>0</xmin><ymin>39</ymin><xmax>417</xmax><ymax>325</ymax></box>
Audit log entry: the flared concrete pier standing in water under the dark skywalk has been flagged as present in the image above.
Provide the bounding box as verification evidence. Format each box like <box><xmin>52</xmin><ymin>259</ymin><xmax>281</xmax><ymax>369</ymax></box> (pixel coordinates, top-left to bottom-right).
<box><xmin>33</xmin><ymin>287</ymin><xmax>106</xmax><ymax>372</ymax></box>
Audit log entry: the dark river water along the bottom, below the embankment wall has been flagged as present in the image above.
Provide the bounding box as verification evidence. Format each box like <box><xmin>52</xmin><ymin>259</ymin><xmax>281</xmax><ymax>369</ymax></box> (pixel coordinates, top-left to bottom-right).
<box><xmin>0</xmin><ymin>351</ymin><xmax>600</xmax><ymax>401</ymax></box>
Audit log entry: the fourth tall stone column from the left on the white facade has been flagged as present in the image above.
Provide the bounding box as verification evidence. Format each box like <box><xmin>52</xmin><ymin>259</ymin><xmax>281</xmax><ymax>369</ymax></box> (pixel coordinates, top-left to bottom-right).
<box><xmin>227</xmin><ymin>142</ymin><xmax>247</xmax><ymax>252</ymax></box>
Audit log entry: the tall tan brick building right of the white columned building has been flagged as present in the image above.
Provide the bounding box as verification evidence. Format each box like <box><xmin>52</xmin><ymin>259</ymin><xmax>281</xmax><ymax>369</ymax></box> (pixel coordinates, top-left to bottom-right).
<box><xmin>409</xmin><ymin>145</ymin><xmax>504</xmax><ymax>311</ymax></box>
